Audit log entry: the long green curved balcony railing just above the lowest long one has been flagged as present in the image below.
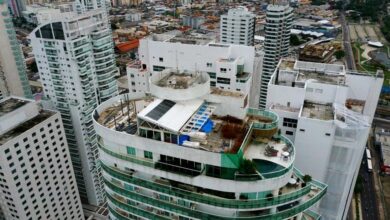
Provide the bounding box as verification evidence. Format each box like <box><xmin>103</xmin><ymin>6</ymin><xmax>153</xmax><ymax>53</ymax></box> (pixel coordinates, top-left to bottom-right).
<box><xmin>101</xmin><ymin>163</ymin><xmax>313</xmax><ymax>209</ymax></box>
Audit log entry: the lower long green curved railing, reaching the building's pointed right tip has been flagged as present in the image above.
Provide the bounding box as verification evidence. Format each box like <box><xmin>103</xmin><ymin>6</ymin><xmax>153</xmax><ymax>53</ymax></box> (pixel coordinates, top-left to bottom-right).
<box><xmin>105</xmin><ymin>174</ymin><xmax>326</xmax><ymax>220</ymax></box>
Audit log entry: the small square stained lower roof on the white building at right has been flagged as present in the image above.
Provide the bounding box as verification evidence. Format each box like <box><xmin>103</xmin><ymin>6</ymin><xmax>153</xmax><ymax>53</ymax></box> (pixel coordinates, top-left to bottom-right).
<box><xmin>301</xmin><ymin>102</ymin><xmax>334</xmax><ymax>121</ymax></box>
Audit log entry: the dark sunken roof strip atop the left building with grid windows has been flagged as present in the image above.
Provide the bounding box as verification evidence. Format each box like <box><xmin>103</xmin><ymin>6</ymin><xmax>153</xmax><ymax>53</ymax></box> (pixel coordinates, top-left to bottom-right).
<box><xmin>0</xmin><ymin>110</ymin><xmax>55</xmax><ymax>145</ymax></box>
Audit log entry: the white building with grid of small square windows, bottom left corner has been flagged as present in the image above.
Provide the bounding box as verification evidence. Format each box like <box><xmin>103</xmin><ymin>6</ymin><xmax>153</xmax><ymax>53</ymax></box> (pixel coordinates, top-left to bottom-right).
<box><xmin>0</xmin><ymin>96</ymin><xmax>84</xmax><ymax>220</ymax></box>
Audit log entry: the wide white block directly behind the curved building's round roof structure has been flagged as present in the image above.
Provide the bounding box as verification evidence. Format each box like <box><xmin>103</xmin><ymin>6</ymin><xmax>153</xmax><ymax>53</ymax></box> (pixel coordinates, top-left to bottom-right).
<box><xmin>127</xmin><ymin>34</ymin><xmax>255</xmax><ymax>103</ymax></box>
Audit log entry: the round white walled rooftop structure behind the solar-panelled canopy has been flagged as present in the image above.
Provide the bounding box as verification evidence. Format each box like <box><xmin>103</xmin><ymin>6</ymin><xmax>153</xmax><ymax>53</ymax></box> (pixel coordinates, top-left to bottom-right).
<box><xmin>149</xmin><ymin>69</ymin><xmax>210</xmax><ymax>101</ymax></box>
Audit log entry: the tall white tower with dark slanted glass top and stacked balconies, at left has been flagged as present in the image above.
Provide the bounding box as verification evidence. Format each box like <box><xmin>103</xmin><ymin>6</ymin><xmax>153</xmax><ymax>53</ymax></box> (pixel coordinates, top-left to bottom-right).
<box><xmin>30</xmin><ymin>1</ymin><xmax>118</xmax><ymax>205</ymax></box>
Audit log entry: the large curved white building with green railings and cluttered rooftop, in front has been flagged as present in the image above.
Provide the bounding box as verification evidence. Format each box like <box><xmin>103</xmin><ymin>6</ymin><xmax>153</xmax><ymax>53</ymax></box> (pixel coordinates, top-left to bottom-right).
<box><xmin>94</xmin><ymin>69</ymin><xmax>327</xmax><ymax>220</ymax></box>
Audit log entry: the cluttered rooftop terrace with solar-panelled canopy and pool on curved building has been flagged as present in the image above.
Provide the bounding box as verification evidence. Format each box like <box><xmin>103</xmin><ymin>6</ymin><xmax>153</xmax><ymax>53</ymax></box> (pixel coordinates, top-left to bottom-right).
<box><xmin>95</xmin><ymin>96</ymin><xmax>294</xmax><ymax>175</ymax></box>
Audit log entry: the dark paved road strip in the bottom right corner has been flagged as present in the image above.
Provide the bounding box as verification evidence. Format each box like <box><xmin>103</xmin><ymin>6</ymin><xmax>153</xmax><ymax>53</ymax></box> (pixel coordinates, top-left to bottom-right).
<box><xmin>359</xmin><ymin>145</ymin><xmax>379</xmax><ymax>220</ymax></box>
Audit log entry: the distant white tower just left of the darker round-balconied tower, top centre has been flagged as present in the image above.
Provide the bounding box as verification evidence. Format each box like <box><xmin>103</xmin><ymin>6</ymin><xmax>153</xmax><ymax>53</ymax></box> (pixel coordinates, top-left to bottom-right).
<box><xmin>220</xmin><ymin>7</ymin><xmax>256</xmax><ymax>46</ymax></box>
